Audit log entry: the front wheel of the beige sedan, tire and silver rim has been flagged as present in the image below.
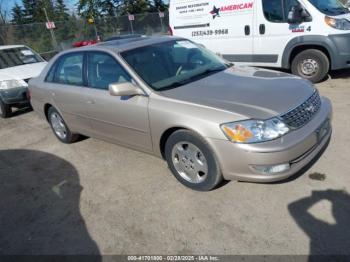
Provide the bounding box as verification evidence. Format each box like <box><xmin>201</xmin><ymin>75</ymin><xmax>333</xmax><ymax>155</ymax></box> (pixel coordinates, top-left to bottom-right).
<box><xmin>165</xmin><ymin>130</ymin><xmax>222</xmax><ymax>191</ymax></box>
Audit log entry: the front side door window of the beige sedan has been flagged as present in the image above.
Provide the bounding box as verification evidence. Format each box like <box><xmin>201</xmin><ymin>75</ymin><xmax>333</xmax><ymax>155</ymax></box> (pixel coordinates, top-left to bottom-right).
<box><xmin>87</xmin><ymin>52</ymin><xmax>131</xmax><ymax>90</ymax></box>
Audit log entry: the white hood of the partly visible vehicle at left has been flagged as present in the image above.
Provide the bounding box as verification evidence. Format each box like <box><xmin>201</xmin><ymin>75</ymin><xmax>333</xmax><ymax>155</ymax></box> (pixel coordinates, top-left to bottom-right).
<box><xmin>0</xmin><ymin>62</ymin><xmax>47</xmax><ymax>81</ymax></box>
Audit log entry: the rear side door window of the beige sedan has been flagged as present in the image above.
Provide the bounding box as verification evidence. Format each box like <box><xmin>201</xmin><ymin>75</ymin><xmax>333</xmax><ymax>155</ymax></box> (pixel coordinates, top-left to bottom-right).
<box><xmin>54</xmin><ymin>53</ymin><xmax>84</xmax><ymax>86</ymax></box>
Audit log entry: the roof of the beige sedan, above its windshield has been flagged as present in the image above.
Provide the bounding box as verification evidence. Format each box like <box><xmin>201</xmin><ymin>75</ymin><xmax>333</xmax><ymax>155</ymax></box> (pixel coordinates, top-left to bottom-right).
<box><xmin>75</xmin><ymin>36</ymin><xmax>183</xmax><ymax>53</ymax></box>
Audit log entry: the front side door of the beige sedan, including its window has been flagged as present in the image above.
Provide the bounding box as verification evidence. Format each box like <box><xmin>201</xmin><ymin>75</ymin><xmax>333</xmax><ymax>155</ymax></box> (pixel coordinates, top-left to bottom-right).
<box><xmin>85</xmin><ymin>51</ymin><xmax>152</xmax><ymax>151</ymax></box>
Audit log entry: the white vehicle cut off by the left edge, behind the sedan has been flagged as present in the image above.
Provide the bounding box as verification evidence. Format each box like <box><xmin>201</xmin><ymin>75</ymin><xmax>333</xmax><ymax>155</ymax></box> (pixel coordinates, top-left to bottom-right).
<box><xmin>0</xmin><ymin>45</ymin><xmax>47</xmax><ymax>118</ymax></box>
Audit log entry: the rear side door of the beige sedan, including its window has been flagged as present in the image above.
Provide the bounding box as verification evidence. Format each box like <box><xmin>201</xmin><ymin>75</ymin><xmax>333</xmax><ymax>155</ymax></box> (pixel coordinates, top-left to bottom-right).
<box><xmin>46</xmin><ymin>52</ymin><xmax>91</xmax><ymax>134</ymax></box>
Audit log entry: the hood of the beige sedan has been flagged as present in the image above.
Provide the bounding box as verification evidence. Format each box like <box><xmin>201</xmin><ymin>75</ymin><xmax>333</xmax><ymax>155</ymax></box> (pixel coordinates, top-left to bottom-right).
<box><xmin>161</xmin><ymin>66</ymin><xmax>314</xmax><ymax>119</ymax></box>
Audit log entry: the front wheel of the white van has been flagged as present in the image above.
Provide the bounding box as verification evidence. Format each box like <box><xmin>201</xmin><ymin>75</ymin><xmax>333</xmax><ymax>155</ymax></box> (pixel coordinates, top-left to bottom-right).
<box><xmin>292</xmin><ymin>49</ymin><xmax>329</xmax><ymax>83</ymax></box>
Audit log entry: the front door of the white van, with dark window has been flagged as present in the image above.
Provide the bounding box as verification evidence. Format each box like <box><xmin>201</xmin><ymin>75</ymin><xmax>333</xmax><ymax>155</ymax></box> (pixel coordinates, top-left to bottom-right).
<box><xmin>253</xmin><ymin>0</ymin><xmax>313</xmax><ymax>67</ymax></box>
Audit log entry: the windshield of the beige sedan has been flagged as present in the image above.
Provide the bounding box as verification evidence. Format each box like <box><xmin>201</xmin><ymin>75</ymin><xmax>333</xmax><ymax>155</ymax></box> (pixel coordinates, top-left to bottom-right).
<box><xmin>121</xmin><ymin>40</ymin><xmax>230</xmax><ymax>91</ymax></box>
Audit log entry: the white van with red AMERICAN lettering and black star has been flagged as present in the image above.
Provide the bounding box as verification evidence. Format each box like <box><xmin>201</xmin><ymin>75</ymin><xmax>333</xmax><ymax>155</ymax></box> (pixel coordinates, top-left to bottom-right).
<box><xmin>170</xmin><ymin>0</ymin><xmax>350</xmax><ymax>82</ymax></box>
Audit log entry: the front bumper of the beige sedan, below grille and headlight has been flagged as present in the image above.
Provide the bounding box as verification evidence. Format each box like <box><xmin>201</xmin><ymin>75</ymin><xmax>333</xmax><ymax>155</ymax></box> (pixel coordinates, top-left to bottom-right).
<box><xmin>208</xmin><ymin>98</ymin><xmax>332</xmax><ymax>182</ymax></box>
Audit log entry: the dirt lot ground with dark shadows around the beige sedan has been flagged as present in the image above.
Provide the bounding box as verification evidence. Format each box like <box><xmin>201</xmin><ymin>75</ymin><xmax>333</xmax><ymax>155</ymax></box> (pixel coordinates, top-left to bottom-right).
<box><xmin>0</xmin><ymin>71</ymin><xmax>350</xmax><ymax>254</ymax></box>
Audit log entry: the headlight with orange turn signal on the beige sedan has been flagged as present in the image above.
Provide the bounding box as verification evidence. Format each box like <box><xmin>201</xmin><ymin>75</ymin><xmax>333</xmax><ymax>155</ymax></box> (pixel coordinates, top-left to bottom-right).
<box><xmin>221</xmin><ymin>118</ymin><xmax>289</xmax><ymax>144</ymax></box>
